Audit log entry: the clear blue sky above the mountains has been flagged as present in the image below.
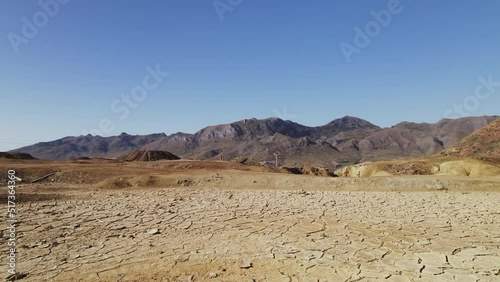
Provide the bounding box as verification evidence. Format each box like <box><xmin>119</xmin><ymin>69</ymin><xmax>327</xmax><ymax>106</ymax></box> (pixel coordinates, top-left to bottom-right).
<box><xmin>0</xmin><ymin>0</ymin><xmax>500</xmax><ymax>150</ymax></box>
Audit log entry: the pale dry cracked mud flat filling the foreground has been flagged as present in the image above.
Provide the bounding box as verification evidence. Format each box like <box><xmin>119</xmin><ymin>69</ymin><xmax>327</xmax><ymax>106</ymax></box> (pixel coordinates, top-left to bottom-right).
<box><xmin>2</xmin><ymin>188</ymin><xmax>500</xmax><ymax>282</ymax></box>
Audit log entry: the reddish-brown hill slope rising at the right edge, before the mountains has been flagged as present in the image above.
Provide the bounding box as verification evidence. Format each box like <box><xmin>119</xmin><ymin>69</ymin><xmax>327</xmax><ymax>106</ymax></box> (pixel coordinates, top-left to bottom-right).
<box><xmin>440</xmin><ymin>118</ymin><xmax>500</xmax><ymax>163</ymax></box>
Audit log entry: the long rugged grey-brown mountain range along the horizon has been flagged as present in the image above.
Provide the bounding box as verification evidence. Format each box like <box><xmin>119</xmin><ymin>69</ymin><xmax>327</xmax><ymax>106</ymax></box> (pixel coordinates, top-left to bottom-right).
<box><xmin>13</xmin><ymin>116</ymin><xmax>498</xmax><ymax>167</ymax></box>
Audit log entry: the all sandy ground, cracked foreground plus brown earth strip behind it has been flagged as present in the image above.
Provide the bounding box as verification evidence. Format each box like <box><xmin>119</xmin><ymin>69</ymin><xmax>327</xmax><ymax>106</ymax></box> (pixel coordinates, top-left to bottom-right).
<box><xmin>0</xmin><ymin>160</ymin><xmax>500</xmax><ymax>281</ymax></box>
